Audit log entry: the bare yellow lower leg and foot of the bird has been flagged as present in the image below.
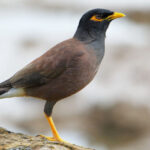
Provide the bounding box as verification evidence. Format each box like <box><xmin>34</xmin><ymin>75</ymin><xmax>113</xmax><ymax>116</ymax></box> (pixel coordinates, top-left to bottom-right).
<box><xmin>42</xmin><ymin>114</ymin><xmax>67</xmax><ymax>143</ymax></box>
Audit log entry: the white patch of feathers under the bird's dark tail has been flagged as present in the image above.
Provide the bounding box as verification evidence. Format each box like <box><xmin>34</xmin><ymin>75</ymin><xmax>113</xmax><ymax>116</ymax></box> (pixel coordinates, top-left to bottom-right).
<box><xmin>0</xmin><ymin>88</ymin><xmax>25</xmax><ymax>99</ymax></box>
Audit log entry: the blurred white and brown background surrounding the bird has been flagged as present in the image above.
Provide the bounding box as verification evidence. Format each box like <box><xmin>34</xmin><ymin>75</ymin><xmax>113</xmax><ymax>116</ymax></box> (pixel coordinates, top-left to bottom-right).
<box><xmin>0</xmin><ymin>0</ymin><xmax>150</xmax><ymax>150</ymax></box>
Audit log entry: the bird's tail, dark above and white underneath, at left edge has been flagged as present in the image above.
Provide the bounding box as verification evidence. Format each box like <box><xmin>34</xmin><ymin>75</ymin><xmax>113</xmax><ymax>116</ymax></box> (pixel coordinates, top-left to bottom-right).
<box><xmin>0</xmin><ymin>80</ymin><xmax>25</xmax><ymax>99</ymax></box>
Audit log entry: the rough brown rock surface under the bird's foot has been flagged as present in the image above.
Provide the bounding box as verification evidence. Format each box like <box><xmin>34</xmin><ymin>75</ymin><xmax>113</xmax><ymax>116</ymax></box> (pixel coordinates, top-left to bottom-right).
<box><xmin>0</xmin><ymin>128</ymin><xmax>92</xmax><ymax>150</ymax></box>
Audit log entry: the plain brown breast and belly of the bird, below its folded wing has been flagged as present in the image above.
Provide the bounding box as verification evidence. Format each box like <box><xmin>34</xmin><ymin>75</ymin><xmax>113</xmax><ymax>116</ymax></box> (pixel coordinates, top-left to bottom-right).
<box><xmin>26</xmin><ymin>40</ymin><xmax>102</xmax><ymax>101</ymax></box>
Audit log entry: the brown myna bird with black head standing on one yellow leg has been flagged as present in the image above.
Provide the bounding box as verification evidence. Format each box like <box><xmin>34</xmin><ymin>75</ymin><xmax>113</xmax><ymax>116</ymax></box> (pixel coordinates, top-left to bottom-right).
<box><xmin>0</xmin><ymin>8</ymin><xmax>125</xmax><ymax>142</ymax></box>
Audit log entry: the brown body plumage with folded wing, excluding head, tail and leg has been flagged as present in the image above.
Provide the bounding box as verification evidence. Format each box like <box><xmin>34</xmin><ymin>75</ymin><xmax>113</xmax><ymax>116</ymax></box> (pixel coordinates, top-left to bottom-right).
<box><xmin>10</xmin><ymin>38</ymin><xmax>99</xmax><ymax>101</ymax></box>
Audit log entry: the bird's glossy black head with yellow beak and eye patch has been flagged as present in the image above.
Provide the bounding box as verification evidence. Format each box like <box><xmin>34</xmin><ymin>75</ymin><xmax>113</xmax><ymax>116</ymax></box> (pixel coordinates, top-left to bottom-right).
<box><xmin>74</xmin><ymin>9</ymin><xmax>125</xmax><ymax>41</ymax></box>
